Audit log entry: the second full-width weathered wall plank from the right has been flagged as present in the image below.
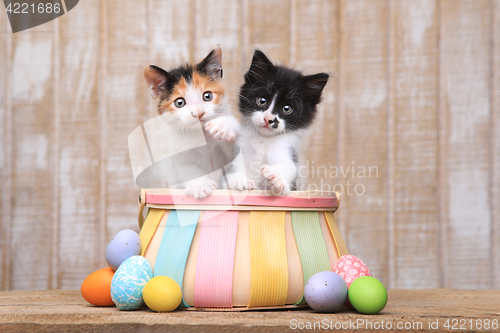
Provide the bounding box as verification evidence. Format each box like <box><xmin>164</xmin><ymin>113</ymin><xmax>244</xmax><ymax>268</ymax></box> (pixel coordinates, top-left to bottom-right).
<box><xmin>389</xmin><ymin>1</ymin><xmax>440</xmax><ymax>288</ymax></box>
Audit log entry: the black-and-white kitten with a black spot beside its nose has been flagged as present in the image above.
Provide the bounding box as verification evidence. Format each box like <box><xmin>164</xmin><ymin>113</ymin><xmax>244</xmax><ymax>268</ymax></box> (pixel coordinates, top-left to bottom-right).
<box><xmin>229</xmin><ymin>50</ymin><xmax>328</xmax><ymax>195</ymax></box>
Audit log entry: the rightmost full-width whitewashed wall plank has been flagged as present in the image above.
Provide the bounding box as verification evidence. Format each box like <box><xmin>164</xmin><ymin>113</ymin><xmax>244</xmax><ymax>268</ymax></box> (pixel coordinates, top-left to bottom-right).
<box><xmin>440</xmin><ymin>1</ymin><xmax>492</xmax><ymax>288</ymax></box>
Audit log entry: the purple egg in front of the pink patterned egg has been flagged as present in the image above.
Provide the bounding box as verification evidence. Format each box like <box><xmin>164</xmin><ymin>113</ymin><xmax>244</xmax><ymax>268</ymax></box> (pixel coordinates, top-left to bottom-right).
<box><xmin>304</xmin><ymin>271</ymin><xmax>347</xmax><ymax>312</ymax></box>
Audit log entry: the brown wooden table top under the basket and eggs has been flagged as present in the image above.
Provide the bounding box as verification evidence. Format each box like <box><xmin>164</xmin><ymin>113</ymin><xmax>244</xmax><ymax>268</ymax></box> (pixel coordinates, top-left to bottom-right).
<box><xmin>0</xmin><ymin>289</ymin><xmax>500</xmax><ymax>333</ymax></box>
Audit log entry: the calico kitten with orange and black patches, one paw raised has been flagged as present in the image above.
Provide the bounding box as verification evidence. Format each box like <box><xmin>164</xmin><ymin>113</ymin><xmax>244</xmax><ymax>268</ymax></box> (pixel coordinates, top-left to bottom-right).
<box><xmin>144</xmin><ymin>46</ymin><xmax>238</xmax><ymax>198</ymax></box>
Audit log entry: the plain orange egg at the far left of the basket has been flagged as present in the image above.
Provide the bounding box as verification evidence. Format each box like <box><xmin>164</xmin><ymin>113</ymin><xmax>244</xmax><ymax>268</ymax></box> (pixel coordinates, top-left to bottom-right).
<box><xmin>80</xmin><ymin>267</ymin><xmax>115</xmax><ymax>306</ymax></box>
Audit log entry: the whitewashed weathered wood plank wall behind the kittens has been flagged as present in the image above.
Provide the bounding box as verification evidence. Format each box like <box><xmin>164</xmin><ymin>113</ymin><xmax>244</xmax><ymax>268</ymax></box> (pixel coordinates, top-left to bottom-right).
<box><xmin>0</xmin><ymin>0</ymin><xmax>500</xmax><ymax>290</ymax></box>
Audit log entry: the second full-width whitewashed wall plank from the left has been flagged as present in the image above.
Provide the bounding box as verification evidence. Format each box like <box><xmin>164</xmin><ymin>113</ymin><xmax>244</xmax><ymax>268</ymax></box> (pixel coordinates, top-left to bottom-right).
<box><xmin>55</xmin><ymin>1</ymin><xmax>101</xmax><ymax>288</ymax></box>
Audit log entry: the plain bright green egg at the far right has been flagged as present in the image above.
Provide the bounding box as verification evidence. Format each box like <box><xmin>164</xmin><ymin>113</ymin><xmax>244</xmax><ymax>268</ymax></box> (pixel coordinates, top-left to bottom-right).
<box><xmin>349</xmin><ymin>276</ymin><xmax>387</xmax><ymax>314</ymax></box>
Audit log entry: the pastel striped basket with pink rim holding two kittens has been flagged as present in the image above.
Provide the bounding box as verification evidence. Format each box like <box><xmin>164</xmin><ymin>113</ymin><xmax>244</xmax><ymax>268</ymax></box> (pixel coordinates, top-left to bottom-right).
<box><xmin>139</xmin><ymin>189</ymin><xmax>347</xmax><ymax>311</ymax></box>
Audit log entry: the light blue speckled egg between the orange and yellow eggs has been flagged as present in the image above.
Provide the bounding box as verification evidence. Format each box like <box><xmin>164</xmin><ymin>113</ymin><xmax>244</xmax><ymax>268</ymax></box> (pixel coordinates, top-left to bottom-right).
<box><xmin>111</xmin><ymin>256</ymin><xmax>153</xmax><ymax>310</ymax></box>
